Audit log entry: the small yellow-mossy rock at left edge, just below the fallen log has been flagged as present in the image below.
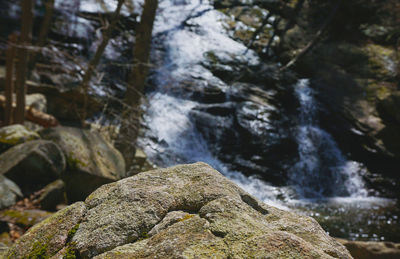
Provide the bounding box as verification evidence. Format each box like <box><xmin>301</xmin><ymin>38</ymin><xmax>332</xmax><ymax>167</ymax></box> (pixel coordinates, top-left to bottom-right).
<box><xmin>0</xmin><ymin>124</ymin><xmax>40</xmax><ymax>152</ymax></box>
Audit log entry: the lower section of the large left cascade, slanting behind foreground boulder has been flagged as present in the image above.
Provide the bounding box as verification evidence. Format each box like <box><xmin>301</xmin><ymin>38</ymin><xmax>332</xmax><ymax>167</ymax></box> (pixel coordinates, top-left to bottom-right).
<box><xmin>140</xmin><ymin>93</ymin><xmax>284</xmax><ymax>208</ymax></box>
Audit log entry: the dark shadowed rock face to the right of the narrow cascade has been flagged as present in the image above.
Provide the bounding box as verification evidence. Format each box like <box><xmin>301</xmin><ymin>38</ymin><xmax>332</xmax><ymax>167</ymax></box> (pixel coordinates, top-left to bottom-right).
<box><xmin>262</xmin><ymin>1</ymin><xmax>400</xmax><ymax>197</ymax></box>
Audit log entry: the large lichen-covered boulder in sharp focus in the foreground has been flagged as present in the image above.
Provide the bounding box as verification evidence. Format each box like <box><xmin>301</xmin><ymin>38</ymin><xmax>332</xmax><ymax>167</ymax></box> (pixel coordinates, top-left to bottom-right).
<box><xmin>6</xmin><ymin>163</ymin><xmax>351</xmax><ymax>259</ymax></box>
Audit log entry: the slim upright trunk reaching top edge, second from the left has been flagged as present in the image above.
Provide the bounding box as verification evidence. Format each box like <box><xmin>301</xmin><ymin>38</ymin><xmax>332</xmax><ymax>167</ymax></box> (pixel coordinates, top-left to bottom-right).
<box><xmin>15</xmin><ymin>0</ymin><xmax>33</xmax><ymax>124</ymax></box>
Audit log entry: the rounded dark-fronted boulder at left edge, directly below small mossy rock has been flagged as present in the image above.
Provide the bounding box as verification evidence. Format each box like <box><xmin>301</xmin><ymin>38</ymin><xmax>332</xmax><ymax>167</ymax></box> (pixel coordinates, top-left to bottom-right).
<box><xmin>0</xmin><ymin>140</ymin><xmax>65</xmax><ymax>194</ymax></box>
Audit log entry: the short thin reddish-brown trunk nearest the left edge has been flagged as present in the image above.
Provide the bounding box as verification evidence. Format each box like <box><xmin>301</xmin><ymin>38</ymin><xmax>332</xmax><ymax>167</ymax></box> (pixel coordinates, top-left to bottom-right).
<box><xmin>4</xmin><ymin>33</ymin><xmax>18</xmax><ymax>125</ymax></box>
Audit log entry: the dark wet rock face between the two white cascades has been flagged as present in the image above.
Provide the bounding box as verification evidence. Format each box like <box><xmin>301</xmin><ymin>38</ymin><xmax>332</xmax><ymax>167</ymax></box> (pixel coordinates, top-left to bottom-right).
<box><xmin>183</xmin><ymin>58</ymin><xmax>297</xmax><ymax>184</ymax></box>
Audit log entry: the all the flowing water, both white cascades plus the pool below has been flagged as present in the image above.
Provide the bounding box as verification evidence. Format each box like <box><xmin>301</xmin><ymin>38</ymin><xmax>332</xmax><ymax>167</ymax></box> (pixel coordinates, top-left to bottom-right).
<box><xmin>139</xmin><ymin>0</ymin><xmax>400</xmax><ymax>241</ymax></box>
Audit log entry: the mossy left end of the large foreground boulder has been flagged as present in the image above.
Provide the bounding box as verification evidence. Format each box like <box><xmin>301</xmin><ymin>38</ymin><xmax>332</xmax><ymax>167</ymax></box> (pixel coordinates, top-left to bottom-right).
<box><xmin>4</xmin><ymin>202</ymin><xmax>86</xmax><ymax>258</ymax></box>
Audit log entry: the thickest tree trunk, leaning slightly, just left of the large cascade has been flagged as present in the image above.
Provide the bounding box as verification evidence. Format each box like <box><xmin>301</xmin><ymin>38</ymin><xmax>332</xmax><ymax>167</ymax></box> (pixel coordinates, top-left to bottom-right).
<box><xmin>115</xmin><ymin>0</ymin><xmax>158</xmax><ymax>170</ymax></box>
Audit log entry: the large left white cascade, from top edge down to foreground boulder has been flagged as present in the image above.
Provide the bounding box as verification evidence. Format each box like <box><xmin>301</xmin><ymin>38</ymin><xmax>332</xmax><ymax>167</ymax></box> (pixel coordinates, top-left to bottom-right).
<box><xmin>139</xmin><ymin>0</ymin><xmax>290</xmax><ymax>207</ymax></box>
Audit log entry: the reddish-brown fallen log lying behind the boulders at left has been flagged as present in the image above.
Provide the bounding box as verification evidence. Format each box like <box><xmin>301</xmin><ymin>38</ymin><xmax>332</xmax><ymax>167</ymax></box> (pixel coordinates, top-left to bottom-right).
<box><xmin>0</xmin><ymin>95</ymin><xmax>59</xmax><ymax>128</ymax></box>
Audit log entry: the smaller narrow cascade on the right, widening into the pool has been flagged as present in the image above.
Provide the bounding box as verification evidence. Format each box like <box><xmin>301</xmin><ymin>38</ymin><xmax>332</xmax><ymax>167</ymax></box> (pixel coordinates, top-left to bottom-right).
<box><xmin>290</xmin><ymin>79</ymin><xmax>367</xmax><ymax>198</ymax></box>
